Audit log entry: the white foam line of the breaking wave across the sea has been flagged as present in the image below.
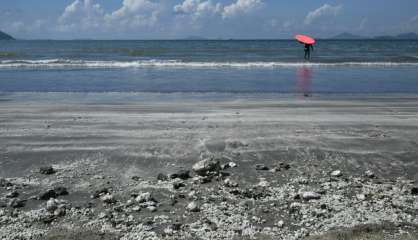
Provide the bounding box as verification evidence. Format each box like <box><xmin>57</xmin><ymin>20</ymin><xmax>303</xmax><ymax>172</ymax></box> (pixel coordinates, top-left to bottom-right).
<box><xmin>0</xmin><ymin>59</ymin><xmax>418</xmax><ymax>69</ymax></box>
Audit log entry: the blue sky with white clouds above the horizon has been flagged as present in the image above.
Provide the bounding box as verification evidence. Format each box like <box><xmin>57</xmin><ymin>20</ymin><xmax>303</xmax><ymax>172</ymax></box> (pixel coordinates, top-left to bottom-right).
<box><xmin>0</xmin><ymin>0</ymin><xmax>418</xmax><ymax>39</ymax></box>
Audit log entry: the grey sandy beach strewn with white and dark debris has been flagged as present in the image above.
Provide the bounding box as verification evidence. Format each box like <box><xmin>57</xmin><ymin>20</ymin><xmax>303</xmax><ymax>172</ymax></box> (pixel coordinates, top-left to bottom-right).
<box><xmin>0</xmin><ymin>94</ymin><xmax>418</xmax><ymax>239</ymax></box>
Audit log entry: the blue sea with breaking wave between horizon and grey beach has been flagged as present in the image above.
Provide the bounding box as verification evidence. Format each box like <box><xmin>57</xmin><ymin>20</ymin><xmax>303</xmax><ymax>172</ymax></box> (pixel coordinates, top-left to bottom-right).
<box><xmin>0</xmin><ymin>40</ymin><xmax>418</xmax><ymax>102</ymax></box>
